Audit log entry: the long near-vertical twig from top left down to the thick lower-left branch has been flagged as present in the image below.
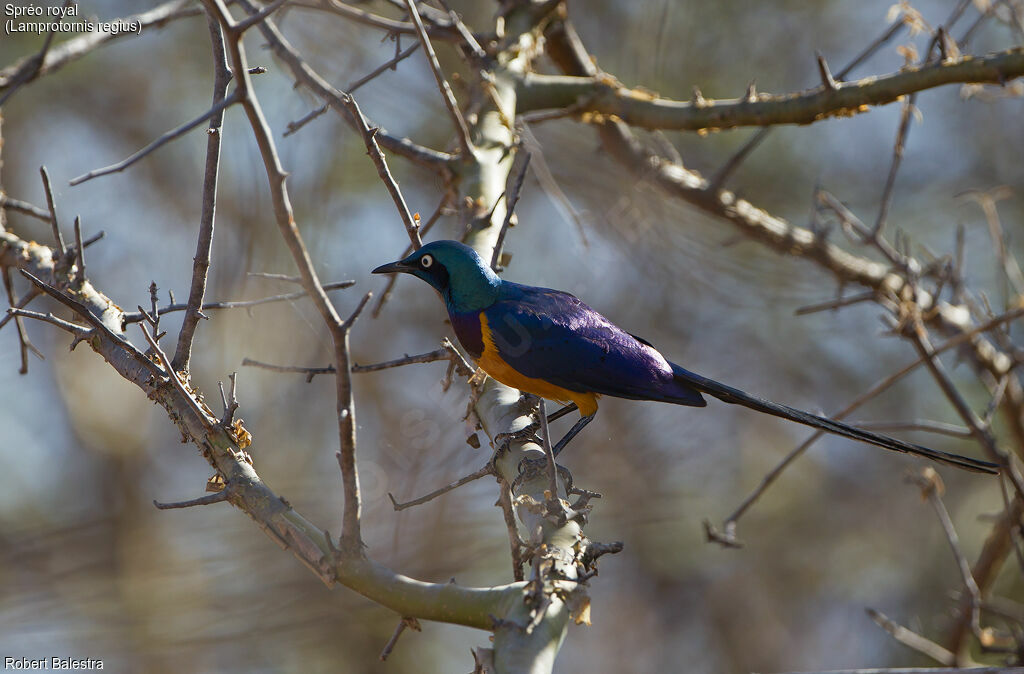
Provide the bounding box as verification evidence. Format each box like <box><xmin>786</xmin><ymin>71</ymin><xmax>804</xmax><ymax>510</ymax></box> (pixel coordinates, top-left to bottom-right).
<box><xmin>172</xmin><ymin>10</ymin><xmax>233</xmax><ymax>371</ymax></box>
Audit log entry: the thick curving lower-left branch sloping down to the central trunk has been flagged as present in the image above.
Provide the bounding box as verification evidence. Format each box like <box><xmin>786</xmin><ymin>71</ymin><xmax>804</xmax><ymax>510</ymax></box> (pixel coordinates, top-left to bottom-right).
<box><xmin>0</xmin><ymin>208</ymin><xmax>523</xmax><ymax>630</ymax></box>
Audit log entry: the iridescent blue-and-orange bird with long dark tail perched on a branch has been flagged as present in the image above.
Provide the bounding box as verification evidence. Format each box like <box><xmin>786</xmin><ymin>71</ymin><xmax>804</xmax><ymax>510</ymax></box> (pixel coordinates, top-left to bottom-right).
<box><xmin>373</xmin><ymin>240</ymin><xmax>998</xmax><ymax>474</ymax></box>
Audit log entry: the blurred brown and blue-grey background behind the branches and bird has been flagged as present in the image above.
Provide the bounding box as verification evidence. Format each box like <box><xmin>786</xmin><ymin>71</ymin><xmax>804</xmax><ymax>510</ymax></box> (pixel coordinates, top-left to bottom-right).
<box><xmin>0</xmin><ymin>0</ymin><xmax>1024</xmax><ymax>673</ymax></box>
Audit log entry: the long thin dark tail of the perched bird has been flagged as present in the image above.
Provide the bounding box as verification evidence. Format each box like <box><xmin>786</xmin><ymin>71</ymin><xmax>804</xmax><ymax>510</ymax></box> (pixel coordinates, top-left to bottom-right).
<box><xmin>672</xmin><ymin>364</ymin><xmax>999</xmax><ymax>475</ymax></box>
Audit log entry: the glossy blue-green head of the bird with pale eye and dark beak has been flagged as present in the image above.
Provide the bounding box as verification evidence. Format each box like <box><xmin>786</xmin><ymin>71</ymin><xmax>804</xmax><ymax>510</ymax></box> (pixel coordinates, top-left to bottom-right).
<box><xmin>374</xmin><ymin>241</ymin><xmax>502</xmax><ymax>312</ymax></box>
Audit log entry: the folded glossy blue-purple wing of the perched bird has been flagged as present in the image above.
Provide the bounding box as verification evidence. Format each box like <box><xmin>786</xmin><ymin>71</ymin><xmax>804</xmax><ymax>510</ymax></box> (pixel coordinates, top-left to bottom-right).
<box><xmin>484</xmin><ymin>282</ymin><xmax>707</xmax><ymax>407</ymax></box>
